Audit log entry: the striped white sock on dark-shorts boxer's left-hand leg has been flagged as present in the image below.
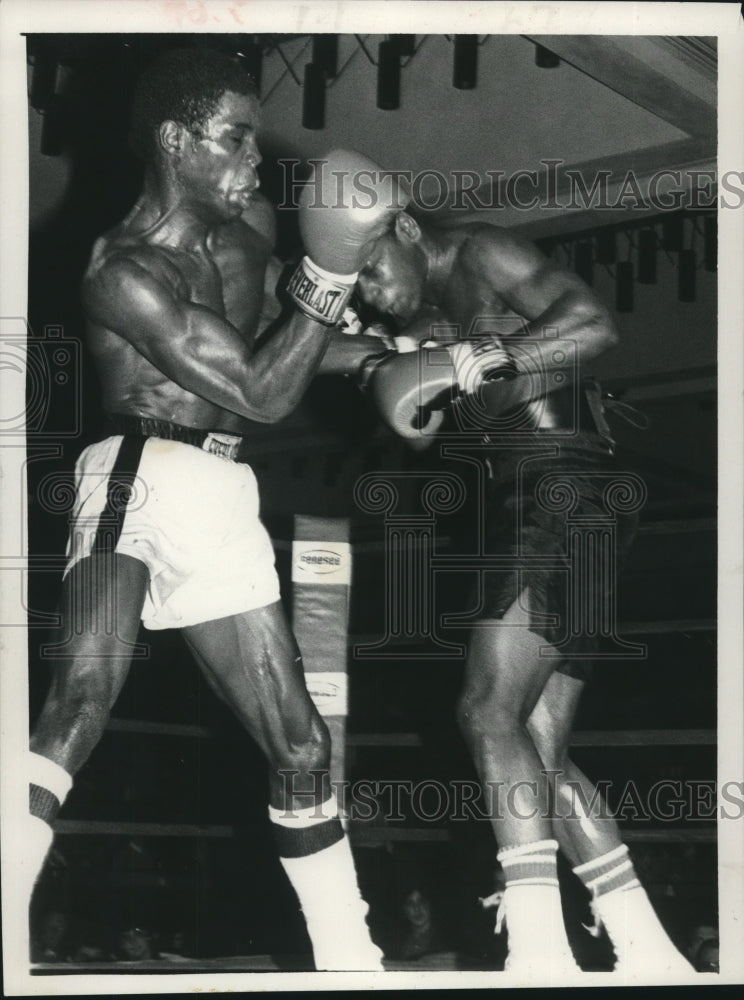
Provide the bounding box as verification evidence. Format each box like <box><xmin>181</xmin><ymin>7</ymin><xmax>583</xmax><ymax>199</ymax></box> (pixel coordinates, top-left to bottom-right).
<box><xmin>497</xmin><ymin>840</ymin><xmax>580</xmax><ymax>977</ymax></box>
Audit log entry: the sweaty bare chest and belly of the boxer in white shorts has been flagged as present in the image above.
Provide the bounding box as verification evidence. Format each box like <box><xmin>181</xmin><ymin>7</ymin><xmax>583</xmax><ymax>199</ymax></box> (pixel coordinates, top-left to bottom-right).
<box><xmin>87</xmin><ymin>209</ymin><xmax>270</xmax><ymax>433</ymax></box>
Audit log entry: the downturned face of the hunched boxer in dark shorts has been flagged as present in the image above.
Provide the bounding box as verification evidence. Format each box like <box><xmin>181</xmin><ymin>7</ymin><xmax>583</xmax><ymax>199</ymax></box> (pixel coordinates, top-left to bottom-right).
<box><xmin>357</xmin><ymin>227</ymin><xmax>425</xmax><ymax>327</ymax></box>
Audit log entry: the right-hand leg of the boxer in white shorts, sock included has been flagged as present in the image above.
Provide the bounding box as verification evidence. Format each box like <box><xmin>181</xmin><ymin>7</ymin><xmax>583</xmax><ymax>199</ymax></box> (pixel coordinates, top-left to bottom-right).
<box><xmin>182</xmin><ymin>602</ymin><xmax>381</xmax><ymax>970</ymax></box>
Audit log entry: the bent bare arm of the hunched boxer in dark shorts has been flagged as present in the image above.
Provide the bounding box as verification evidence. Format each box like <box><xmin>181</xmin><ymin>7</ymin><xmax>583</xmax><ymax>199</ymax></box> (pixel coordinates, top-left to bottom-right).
<box><xmin>464</xmin><ymin>227</ymin><xmax>617</xmax><ymax>371</ymax></box>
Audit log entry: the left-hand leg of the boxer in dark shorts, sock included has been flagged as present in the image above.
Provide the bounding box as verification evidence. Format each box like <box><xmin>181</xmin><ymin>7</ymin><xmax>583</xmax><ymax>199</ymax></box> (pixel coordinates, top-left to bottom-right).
<box><xmin>458</xmin><ymin>591</ymin><xmax>578</xmax><ymax>977</ymax></box>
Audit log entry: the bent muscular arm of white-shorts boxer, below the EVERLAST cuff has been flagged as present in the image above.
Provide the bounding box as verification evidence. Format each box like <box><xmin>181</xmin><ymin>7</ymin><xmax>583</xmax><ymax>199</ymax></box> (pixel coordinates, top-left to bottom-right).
<box><xmin>83</xmin><ymin>255</ymin><xmax>329</xmax><ymax>423</ymax></box>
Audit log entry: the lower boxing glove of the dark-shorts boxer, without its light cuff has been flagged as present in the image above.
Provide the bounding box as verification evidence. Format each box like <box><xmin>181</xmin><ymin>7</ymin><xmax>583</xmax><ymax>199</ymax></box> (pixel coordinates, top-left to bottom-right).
<box><xmin>362</xmin><ymin>347</ymin><xmax>457</xmax><ymax>440</ymax></box>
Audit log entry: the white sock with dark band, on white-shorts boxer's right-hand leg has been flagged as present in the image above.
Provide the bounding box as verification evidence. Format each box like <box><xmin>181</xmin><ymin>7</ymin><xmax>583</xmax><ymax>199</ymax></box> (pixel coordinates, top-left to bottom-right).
<box><xmin>269</xmin><ymin>797</ymin><xmax>382</xmax><ymax>971</ymax></box>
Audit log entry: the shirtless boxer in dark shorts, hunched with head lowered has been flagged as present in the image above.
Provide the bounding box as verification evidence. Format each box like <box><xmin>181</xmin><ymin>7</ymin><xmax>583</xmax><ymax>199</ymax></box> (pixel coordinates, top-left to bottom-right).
<box><xmin>328</xmin><ymin>148</ymin><xmax>690</xmax><ymax>978</ymax></box>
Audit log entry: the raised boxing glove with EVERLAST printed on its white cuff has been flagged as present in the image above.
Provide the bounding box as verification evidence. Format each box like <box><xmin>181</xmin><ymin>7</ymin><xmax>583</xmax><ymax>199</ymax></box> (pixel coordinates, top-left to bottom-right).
<box><xmin>287</xmin><ymin>150</ymin><xmax>409</xmax><ymax>325</ymax></box>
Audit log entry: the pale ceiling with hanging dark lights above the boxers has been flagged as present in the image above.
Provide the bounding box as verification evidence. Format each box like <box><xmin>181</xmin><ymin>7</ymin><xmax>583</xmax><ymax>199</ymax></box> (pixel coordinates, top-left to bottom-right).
<box><xmin>262</xmin><ymin>35</ymin><xmax>716</xmax><ymax>236</ymax></box>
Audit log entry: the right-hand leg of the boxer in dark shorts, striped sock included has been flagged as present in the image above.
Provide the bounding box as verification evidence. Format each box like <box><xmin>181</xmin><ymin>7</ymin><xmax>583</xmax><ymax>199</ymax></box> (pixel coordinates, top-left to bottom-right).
<box><xmin>527</xmin><ymin>672</ymin><xmax>691</xmax><ymax>977</ymax></box>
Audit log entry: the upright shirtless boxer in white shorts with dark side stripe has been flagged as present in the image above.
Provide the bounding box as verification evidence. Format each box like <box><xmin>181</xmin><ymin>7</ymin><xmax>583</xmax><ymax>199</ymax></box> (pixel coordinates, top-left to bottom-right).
<box><xmin>24</xmin><ymin>49</ymin><xmax>396</xmax><ymax>970</ymax></box>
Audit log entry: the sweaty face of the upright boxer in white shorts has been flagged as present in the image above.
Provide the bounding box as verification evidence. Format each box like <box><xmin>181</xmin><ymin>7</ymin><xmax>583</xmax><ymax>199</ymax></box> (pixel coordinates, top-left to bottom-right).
<box><xmin>178</xmin><ymin>91</ymin><xmax>261</xmax><ymax>219</ymax></box>
